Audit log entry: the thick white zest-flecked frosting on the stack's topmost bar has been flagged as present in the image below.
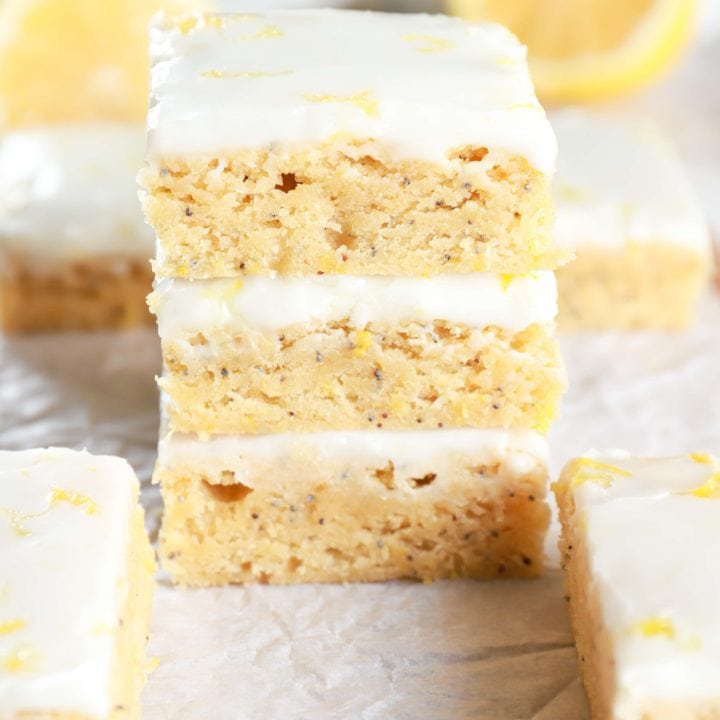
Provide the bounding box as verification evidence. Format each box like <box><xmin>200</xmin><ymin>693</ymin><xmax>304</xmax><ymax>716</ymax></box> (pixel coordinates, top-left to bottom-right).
<box><xmin>148</xmin><ymin>10</ymin><xmax>556</xmax><ymax>172</ymax></box>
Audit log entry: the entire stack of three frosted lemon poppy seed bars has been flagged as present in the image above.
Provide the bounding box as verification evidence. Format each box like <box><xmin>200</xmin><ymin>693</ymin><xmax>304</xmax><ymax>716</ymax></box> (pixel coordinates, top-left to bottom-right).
<box><xmin>141</xmin><ymin>10</ymin><xmax>565</xmax><ymax>585</ymax></box>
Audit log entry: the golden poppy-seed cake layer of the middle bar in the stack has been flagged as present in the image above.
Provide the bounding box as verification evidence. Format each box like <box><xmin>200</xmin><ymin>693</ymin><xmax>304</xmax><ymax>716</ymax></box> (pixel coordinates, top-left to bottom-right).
<box><xmin>159</xmin><ymin>321</ymin><xmax>565</xmax><ymax>434</ymax></box>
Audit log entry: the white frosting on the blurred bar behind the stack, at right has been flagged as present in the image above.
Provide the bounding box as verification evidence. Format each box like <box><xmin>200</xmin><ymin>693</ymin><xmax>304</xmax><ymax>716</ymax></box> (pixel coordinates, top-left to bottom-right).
<box><xmin>551</xmin><ymin>110</ymin><xmax>710</xmax><ymax>253</ymax></box>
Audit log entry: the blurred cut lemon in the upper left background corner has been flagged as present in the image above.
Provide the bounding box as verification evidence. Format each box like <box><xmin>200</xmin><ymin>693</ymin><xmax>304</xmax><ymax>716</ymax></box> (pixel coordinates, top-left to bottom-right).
<box><xmin>0</xmin><ymin>0</ymin><xmax>208</xmax><ymax>127</ymax></box>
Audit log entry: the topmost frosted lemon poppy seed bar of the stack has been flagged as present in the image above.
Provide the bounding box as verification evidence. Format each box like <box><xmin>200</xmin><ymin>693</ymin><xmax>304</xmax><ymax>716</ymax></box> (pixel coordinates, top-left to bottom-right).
<box><xmin>140</xmin><ymin>10</ymin><xmax>562</xmax><ymax>278</ymax></box>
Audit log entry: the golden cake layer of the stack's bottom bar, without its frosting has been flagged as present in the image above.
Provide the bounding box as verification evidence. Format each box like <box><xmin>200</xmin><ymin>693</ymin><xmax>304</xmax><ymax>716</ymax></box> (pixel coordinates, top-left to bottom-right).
<box><xmin>155</xmin><ymin>457</ymin><xmax>549</xmax><ymax>586</ymax></box>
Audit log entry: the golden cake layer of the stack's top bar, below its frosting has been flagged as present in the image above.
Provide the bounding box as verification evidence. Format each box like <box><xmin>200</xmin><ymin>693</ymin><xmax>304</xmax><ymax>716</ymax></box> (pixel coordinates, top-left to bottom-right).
<box><xmin>140</xmin><ymin>140</ymin><xmax>556</xmax><ymax>278</ymax></box>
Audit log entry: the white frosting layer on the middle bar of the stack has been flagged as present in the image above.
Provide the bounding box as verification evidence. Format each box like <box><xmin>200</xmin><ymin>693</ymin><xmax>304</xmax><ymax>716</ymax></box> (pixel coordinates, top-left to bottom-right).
<box><xmin>150</xmin><ymin>272</ymin><xmax>557</xmax><ymax>338</ymax></box>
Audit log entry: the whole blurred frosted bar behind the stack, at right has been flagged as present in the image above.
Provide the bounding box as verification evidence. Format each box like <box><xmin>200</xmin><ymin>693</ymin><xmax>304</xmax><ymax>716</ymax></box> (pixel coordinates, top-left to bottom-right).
<box><xmin>552</xmin><ymin>110</ymin><xmax>712</xmax><ymax>330</ymax></box>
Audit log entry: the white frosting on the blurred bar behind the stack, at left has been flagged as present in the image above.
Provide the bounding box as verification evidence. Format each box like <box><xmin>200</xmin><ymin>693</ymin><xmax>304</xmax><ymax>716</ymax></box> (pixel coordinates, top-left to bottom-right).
<box><xmin>0</xmin><ymin>123</ymin><xmax>154</xmax><ymax>263</ymax></box>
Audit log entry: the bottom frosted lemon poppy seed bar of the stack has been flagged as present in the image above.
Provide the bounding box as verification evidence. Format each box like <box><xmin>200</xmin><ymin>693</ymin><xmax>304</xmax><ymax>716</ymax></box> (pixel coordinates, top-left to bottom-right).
<box><xmin>155</xmin><ymin>429</ymin><xmax>550</xmax><ymax>585</ymax></box>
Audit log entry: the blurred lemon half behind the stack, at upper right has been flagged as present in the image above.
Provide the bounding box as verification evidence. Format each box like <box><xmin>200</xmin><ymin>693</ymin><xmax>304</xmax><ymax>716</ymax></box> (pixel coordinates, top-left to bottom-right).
<box><xmin>447</xmin><ymin>0</ymin><xmax>697</xmax><ymax>102</ymax></box>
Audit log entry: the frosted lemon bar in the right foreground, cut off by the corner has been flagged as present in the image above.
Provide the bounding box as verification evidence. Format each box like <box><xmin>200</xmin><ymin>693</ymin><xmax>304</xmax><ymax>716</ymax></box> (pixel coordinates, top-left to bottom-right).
<box><xmin>555</xmin><ymin>453</ymin><xmax>720</xmax><ymax>720</ymax></box>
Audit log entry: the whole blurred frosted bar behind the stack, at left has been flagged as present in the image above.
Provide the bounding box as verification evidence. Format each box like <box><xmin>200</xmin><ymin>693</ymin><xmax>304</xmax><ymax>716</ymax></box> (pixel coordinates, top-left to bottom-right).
<box><xmin>0</xmin><ymin>123</ymin><xmax>154</xmax><ymax>332</ymax></box>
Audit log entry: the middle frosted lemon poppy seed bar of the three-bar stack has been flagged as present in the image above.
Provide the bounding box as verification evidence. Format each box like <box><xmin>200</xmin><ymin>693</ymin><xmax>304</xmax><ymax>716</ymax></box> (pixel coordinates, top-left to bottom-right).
<box><xmin>151</xmin><ymin>271</ymin><xmax>565</xmax><ymax>435</ymax></box>
